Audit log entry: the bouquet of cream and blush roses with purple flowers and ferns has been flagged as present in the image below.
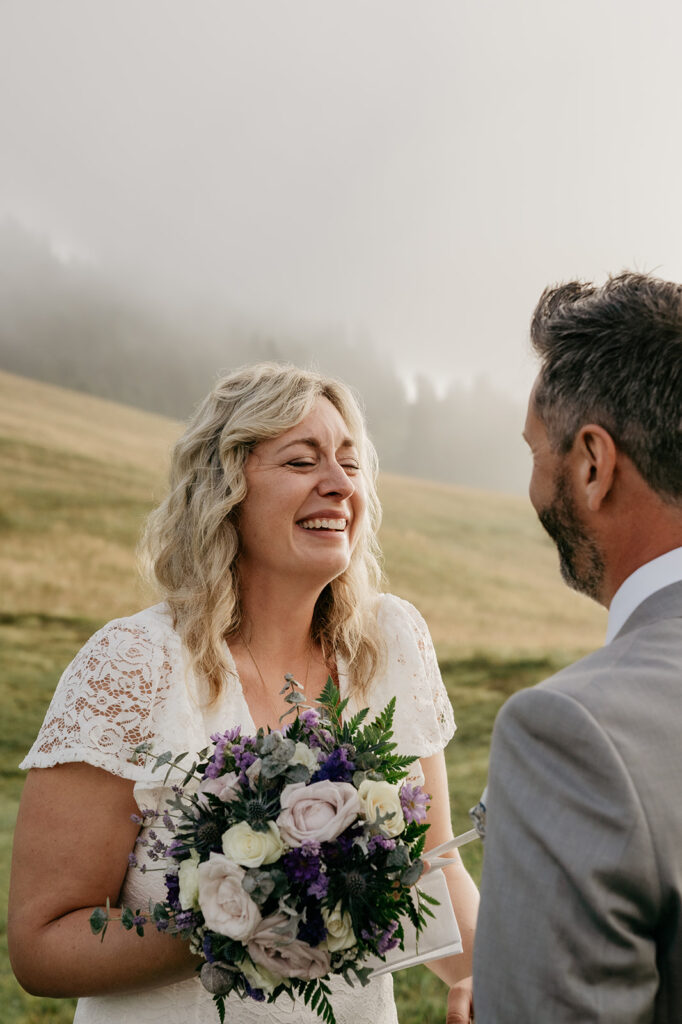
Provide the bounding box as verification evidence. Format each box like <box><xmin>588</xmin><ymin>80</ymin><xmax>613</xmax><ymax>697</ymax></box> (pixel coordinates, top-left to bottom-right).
<box><xmin>90</xmin><ymin>676</ymin><xmax>437</xmax><ymax>1024</ymax></box>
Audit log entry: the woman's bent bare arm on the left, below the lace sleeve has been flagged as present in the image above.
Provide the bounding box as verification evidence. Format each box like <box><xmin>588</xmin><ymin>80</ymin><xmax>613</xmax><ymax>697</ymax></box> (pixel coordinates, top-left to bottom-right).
<box><xmin>8</xmin><ymin>763</ymin><xmax>200</xmax><ymax>997</ymax></box>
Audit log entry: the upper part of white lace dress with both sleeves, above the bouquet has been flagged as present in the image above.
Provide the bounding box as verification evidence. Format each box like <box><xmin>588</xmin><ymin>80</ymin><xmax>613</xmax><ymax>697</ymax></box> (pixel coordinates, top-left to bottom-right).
<box><xmin>20</xmin><ymin>594</ymin><xmax>455</xmax><ymax>781</ymax></box>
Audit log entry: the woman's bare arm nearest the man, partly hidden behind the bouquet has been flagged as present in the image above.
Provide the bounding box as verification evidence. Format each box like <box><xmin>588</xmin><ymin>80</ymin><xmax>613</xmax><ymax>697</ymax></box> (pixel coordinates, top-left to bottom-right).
<box><xmin>421</xmin><ymin>754</ymin><xmax>478</xmax><ymax>1024</ymax></box>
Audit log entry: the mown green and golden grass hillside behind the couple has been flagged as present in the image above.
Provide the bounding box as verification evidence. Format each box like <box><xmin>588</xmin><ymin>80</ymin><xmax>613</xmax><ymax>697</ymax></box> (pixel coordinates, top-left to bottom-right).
<box><xmin>0</xmin><ymin>373</ymin><xmax>605</xmax><ymax>1024</ymax></box>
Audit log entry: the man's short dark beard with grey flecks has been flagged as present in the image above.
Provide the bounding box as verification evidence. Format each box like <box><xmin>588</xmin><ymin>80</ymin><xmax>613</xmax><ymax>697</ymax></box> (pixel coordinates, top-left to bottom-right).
<box><xmin>538</xmin><ymin>470</ymin><xmax>605</xmax><ymax>601</ymax></box>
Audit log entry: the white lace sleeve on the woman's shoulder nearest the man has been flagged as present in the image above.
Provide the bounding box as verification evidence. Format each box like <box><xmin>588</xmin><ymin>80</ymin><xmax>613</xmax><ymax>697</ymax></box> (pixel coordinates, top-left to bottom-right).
<box><xmin>379</xmin><ymin>594</ymin><xmax>456</xmax><ymax>757</ymax></box>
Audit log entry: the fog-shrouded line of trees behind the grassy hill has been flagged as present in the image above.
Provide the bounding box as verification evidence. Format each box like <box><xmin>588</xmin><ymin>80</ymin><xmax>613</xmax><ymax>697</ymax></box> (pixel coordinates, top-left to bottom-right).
<box><xmin>0</xmin><ymin>221</ymin><xmax>527</xmax><ymax>493</ymax></box>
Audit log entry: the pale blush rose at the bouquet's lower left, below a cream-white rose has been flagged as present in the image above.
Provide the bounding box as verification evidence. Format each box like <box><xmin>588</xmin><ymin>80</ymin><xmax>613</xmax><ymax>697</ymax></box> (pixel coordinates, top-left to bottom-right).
<box><xmin>198</xmin><ymin>853</ymin><xmax>262</xmax><ymax>942</ymax></box>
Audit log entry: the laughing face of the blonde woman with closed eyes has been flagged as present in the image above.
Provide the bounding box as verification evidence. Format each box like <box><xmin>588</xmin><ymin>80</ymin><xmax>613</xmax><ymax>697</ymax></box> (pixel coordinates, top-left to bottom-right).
<box><xmin>239</xmin><ymin>398</ymin><xmax>366</xmax><ymax>588</ymax></box>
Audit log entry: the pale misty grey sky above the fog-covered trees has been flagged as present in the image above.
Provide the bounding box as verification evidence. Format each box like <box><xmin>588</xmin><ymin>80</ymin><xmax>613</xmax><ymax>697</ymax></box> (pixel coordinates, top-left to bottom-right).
<box><xmin>0</xmin><ymin>0</ymin><xmax>682</xmax><ymax>395</ymax></box>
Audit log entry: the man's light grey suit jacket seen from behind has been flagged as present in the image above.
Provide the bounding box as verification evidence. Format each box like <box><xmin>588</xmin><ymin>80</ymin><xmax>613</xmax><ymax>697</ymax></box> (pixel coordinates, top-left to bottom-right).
<box><xmin>474</xmin><ymin>583</ymin><xmax>682</xmax><ymax>1024</ymax></box>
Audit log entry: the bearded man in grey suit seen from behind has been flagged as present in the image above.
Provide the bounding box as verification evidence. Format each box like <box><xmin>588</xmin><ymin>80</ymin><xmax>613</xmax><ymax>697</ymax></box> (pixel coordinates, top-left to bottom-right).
<box><xmin>474</xmin><ymin>273</ymin><xmax>682</xmax><ymax>1024</ymax></box>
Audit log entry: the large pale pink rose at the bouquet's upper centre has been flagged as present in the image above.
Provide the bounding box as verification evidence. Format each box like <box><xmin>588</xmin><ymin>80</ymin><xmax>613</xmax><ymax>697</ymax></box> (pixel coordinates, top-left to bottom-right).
<box><xmin>278</xmin><ymin>779</ymin><xmax>360</xmax><ymax>846</ymax></box>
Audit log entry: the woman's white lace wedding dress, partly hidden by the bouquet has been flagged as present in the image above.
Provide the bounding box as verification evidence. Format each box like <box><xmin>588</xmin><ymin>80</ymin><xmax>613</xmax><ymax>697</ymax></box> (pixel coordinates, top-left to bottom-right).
<box><xmin>20</xmin><ymin>594</ymin><xmax>455</xmax><ymax>1024</ymax></box>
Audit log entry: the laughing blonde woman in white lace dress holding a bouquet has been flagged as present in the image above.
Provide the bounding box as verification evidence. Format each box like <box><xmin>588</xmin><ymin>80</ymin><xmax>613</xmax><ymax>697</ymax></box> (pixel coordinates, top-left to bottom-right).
<box><xmin>9</xmin><ymin>364</ymin><xmax>477</xmax><ymax>1024</ymax></box>
